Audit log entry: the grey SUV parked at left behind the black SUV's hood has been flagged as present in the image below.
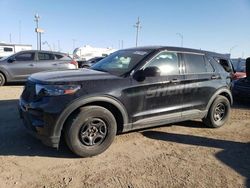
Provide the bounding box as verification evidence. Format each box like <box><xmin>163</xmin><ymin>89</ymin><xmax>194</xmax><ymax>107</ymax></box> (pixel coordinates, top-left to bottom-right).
<box><xmin>0</xmin><ymin>50</ymin><xmax>78</xmax><ymax>86</ymax></box>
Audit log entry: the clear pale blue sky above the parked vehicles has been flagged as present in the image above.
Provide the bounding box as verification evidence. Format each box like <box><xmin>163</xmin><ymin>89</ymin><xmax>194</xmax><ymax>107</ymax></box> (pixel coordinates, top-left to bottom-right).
<box><xmin>0</xmin><ymin>0</ymin><xmax>250</xmax><ymax>57</ymax></box>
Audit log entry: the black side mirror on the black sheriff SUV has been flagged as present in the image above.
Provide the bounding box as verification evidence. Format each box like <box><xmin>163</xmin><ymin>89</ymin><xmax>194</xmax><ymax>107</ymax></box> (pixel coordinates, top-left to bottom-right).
<box><xmin>133</xmin><ymin>66</ymin><xmax>161</xmax><ymax>82</ymax></box>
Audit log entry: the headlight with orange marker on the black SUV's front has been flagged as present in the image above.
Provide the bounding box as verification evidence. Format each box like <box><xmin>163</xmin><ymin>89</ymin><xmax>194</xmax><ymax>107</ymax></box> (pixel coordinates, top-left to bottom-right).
<box><xmin>36</xmin><ymin>84</ymin><xmax>81</xmax><ymax>96</ymax></box>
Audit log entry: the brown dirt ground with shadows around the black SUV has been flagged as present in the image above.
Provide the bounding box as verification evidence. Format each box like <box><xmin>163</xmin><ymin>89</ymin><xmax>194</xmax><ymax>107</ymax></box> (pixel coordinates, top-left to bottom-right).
<box><xmin>0</xmin><ymin>86</ymin><xmax>250</xmax><ymax>188</ymax></box>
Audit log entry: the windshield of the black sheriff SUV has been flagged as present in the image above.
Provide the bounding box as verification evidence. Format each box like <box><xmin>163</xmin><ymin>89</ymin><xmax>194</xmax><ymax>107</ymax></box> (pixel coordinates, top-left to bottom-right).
<box><xmin>91</xmin><ymin>50</ymin><xmax>152</xmax><ymax>76</ymax></box>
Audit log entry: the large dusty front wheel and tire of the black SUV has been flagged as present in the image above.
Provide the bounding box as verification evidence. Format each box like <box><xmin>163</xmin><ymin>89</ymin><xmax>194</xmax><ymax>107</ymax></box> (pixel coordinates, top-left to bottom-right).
<box><xmin>65</xmin><ymin>106</ymin><xmax>117</xmax><ymax>157</ymax></box>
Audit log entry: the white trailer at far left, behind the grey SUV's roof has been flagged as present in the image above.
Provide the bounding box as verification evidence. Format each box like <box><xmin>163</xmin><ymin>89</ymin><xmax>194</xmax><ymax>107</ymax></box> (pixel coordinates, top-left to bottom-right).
<box><xmin>0</xmin><ymin>43</ymin><xmax>32</xmax><ymax>58</ymax></box>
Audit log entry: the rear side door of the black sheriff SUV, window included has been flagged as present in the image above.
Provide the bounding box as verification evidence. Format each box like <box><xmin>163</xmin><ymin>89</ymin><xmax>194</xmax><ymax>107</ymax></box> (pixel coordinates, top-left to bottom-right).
<box><xmin>182</xmin><ymin>53</ymin><xmax>221</xmax><ymax>115</ymax></box>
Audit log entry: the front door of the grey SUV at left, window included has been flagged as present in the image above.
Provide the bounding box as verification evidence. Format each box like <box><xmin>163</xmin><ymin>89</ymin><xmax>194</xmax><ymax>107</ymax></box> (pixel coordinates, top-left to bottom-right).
<box><xmin>8</xmin><ymin>52</ymin><xmax>35</xmax><ymax>80</ymax></box>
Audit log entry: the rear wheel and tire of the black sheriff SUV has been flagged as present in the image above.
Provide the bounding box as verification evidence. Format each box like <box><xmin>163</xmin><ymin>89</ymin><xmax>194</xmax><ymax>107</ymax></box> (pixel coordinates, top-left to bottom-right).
<box><xmin>203</xmin><ymin>95</ymin><xmax>231</xmax><ymax>128</ymax></box>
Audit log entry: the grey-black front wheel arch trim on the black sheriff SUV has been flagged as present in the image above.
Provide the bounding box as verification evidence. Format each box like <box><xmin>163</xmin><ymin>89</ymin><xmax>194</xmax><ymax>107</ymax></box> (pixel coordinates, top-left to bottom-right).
<box><xmin>53</xmin><ymin>96</ymin><xmax>128</xmax><ymax>141</ymax></box>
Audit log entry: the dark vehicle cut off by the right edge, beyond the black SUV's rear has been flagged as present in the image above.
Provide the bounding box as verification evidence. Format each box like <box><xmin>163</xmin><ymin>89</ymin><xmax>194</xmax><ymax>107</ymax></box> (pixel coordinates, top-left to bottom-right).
<box><xmin>233</xmin><ymin>58</ymin><xmax>250</xmax><ymax>101</ymax></box>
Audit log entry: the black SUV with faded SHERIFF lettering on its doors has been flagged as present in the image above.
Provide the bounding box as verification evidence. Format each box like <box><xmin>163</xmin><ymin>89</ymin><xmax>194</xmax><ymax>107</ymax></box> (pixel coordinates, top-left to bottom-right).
<box><xmin>19</xmin><ymin>47</ymin><xmax>232</xmax><ymax>157</ymax></box>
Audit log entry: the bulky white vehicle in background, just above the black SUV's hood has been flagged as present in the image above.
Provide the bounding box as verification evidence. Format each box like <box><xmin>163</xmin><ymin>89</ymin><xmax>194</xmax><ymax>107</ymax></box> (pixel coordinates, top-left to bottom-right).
<box><xmin>73</xmin><ymin>45</ymin><xmax>116</xmax><ymax>62</ymax></box>
